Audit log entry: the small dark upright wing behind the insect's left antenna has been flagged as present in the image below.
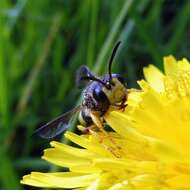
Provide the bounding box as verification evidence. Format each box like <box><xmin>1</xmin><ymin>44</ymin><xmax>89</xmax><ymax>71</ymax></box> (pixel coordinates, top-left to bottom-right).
<box><xmin>76</xmin><ymin>65</ymin><xmax>94</xmax><ymax>88</ymax></box>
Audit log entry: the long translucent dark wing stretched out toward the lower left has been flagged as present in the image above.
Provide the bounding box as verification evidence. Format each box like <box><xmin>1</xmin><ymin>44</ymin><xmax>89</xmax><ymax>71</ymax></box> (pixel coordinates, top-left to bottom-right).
<box><xmin>34</xmin><ymin>106</ymin><xmax>81</xmax><ymax>139</ymax></box>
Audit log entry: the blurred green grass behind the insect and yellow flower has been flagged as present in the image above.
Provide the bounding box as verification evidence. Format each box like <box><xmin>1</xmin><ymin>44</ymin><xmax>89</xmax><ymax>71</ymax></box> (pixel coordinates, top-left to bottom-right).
<box><xmin>0</xmin><ymin>0</ymin><xmax>190</xmax><ymax>190</ymax></box>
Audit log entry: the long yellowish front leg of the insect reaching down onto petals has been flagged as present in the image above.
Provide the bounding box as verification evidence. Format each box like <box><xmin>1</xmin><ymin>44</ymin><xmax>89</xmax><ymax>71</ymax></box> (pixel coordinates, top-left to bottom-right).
<box><xmin>90</xmin><ymin>112</ymin><xmax>121</xmax><ymax>158</ymax></box>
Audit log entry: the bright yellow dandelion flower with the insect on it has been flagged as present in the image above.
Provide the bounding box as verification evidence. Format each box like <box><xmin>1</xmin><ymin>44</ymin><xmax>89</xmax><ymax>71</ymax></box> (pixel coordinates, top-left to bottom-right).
<box><xmin>21</xmin><ymin>56</ymin><xmax>190</xmax><ymax>190</ymax></box>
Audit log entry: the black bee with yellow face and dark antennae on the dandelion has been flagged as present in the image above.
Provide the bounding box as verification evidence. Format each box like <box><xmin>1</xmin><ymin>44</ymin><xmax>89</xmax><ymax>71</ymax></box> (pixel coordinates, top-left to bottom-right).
<box><xmin>35</xmin><ymin>41</ymin><xmax>128</xmax><ymax>138</ymax></box>
